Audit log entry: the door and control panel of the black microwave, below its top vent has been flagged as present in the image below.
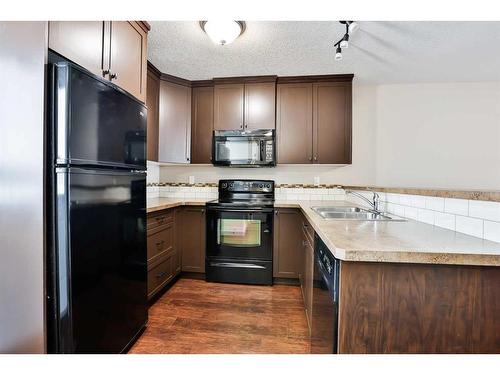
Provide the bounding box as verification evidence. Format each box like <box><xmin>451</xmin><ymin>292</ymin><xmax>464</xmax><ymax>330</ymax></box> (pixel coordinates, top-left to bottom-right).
<box><xmin>212</xmin><ymin>136</ymin><xmax>275</xmax><ymax>167</ymax></box>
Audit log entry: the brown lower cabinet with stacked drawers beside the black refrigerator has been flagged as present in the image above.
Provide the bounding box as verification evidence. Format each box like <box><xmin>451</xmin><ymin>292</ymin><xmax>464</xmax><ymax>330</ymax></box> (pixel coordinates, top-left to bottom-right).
<box><xmin>147</xmin><ymin>209</ymin><xmax>180</xmax><ymax>299</ymax></box>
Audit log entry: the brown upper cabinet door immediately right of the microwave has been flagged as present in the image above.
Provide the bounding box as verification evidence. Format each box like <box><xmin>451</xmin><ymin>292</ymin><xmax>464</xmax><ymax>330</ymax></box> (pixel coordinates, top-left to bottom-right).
<box><xmin>276</xmin><ymin>83</ymin><xmax>312</xmax><ymax>164</ymax></box>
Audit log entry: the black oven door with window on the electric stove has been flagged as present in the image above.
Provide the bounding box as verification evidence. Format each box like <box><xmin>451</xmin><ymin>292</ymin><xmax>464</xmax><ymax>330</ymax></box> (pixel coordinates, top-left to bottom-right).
<box><xmin>207</xmin><ymin>207</ymin><xmax>273</xmax><ymax>260</ymax></box>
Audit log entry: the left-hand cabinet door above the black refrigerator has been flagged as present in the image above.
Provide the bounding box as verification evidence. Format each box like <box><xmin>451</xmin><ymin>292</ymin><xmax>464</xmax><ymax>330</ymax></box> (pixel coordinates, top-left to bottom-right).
<box><xmin>49</xmin><ymin>21</ymin><xmax>104</xmax><ymax>77</ymax></box>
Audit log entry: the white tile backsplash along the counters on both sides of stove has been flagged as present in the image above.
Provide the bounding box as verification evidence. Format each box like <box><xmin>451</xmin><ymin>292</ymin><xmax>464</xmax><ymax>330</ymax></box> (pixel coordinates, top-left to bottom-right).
<box><xmin>147</xmin><ymin>183</ymin><xmax>500</xmax><ymax>242</ymax></box>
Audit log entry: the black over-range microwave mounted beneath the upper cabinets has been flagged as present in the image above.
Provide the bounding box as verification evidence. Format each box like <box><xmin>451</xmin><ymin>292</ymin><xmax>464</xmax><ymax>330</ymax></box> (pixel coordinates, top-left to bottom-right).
<box><xmin>212</xmin><ymin>129</ymin><xmax>276</xmax><ymax>167</ymax></box>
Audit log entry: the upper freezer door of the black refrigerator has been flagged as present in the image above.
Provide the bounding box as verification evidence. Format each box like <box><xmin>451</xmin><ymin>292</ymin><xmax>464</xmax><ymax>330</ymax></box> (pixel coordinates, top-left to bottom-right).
<box><xmin>51</xmin><ymin>62</ymin><xmax>147</xmax><ymax>169</ymax></box>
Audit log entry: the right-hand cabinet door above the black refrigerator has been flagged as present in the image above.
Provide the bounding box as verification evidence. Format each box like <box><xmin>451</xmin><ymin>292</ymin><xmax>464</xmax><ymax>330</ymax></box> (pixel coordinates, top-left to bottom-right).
<box><xmin>109</xmin><ymin>21</ymin><xmax>147</xmax><ymax>102</ymax></box>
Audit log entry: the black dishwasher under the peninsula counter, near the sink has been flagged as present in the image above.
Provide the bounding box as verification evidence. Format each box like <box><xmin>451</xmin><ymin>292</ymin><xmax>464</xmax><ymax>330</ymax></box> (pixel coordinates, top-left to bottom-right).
<box><xmin>311</xmin><ymin>233</ymin><xmax>340</xmax><ymax>354</ymax></box>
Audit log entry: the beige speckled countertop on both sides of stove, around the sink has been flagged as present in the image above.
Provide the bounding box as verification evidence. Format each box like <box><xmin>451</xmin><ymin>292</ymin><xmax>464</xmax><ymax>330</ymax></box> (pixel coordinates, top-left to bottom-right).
<box><xmin>147</xmin><ymin>198</ymin><xmax>500</xmax><ymax>266</ymax></box>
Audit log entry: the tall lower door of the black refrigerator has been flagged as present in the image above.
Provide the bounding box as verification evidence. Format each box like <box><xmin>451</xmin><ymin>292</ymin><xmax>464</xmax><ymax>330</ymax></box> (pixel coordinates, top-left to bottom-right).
<box><xmin>49</xmin><ymin>168</ymin><xmax>147</xmax><ymax>353</ymax></box>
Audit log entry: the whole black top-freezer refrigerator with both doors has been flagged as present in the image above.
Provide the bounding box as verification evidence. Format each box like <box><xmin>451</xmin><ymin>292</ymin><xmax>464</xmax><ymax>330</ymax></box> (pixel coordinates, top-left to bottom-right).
<box><xmin>46</xmin><ymin>55</ymin><xmax>148</xmax><ymax>353</ymax></box>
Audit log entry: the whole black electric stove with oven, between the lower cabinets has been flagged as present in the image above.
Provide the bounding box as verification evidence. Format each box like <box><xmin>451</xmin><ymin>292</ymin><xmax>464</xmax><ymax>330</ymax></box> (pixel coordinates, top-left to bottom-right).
<box><xmin>206</xmin><ymin>180</ymin><xmax>274</xmax><ymax>285</ymax></box>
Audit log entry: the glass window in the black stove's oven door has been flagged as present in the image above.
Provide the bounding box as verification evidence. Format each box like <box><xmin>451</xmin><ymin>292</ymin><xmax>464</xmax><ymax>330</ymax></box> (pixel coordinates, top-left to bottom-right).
<box><xmin>217</xmin><ymin>219</ymin><xmax>261</xmax><ymax>247</ymax></box>
